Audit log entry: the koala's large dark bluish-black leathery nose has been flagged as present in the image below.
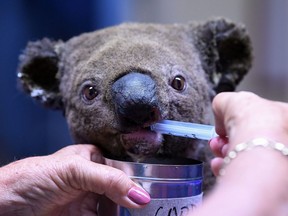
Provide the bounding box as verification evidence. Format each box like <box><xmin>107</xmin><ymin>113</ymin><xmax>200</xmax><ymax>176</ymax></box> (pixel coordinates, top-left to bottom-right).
<box><xmin>112</xmin><ymin>72</ymin><xmax>160</xmax><ymax>126</ymax></box>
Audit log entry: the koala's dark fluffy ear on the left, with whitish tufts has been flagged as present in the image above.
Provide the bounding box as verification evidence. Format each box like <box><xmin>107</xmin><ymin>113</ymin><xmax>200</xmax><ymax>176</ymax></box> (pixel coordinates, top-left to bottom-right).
<box><xmin>18</xmin><ymin>38</ymin><xmax>63</xmax><ymax>109</ymax></box>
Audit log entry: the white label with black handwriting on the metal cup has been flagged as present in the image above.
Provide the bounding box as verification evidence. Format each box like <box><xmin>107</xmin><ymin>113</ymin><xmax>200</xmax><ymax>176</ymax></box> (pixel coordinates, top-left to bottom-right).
<box><xmin>128</xmin><ymin>193</ymin><xmax>203</xmax><ymax>216</ymax></box>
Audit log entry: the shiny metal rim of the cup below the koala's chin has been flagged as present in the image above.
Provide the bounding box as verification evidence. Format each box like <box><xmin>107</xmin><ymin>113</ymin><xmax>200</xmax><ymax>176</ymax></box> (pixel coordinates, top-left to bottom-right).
<box><xmin>104</xmin><ymin>157</ymin><xmax>203</xmax><ymax>181</ymax></box>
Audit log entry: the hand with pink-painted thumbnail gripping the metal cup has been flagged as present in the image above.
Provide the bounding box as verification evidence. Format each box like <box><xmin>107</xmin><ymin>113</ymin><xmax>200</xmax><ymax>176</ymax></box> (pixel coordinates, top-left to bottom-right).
<box><xmin>0</xmin><ymin>145</ymin><xmax>150</xmax><ymax>216</ymax></box>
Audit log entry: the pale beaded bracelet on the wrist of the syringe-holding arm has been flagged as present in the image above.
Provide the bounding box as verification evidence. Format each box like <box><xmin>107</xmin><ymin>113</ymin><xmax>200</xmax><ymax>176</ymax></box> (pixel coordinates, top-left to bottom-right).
<box><xmin>219</xmin><ymin>137</ymin><xmax>288</xmax><ymax>176</ymax></box>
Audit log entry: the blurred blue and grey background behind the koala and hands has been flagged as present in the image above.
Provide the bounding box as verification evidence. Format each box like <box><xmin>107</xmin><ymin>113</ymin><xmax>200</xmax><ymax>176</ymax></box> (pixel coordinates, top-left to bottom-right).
<box><xmin>0</xmin><ymin>0</ymin><xmax>288</xmax><ymax>165</ymax></box>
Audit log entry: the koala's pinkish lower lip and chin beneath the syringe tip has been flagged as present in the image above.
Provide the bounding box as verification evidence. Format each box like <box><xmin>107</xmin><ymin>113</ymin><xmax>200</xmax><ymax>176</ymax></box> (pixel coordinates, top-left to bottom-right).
<box><xmin>121</xmin><ymin>128</ymin><xmax>162</xmax><ymax>158</ymax></box>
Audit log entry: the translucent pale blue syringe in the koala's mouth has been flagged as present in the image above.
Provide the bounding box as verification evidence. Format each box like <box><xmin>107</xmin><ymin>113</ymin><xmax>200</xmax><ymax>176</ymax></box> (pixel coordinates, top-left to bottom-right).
<box><xmin>151</xmin><ymin>120</ymin><xmax>218</xmax><ymax>140</ymax></box>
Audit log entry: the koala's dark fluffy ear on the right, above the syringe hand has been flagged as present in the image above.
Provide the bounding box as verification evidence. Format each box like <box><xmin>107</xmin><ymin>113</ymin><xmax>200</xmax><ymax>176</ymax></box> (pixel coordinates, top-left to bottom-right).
<box><xmin>195</xmin><ymin>19</ymin><xmax>252</xmax><ymax>93</ymax></box>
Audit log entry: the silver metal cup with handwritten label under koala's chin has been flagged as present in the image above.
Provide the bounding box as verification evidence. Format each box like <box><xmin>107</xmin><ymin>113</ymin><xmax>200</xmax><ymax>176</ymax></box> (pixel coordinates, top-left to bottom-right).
<box><xmin>99</xmin><ymin>158</ymin><xmax>203</xmax><ymax>216</ymax></box>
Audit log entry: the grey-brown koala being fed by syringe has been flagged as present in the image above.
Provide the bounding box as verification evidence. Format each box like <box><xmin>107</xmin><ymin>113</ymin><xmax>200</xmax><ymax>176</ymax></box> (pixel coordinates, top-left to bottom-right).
<box><xmin>18</xmin><ymin>18</ymin><xmax>252</xmax><ymax>191</ymax></box>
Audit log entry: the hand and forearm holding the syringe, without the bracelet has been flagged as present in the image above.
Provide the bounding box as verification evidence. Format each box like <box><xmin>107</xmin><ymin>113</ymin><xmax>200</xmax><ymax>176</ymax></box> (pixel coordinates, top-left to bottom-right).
<box><xmin>191</xmin><ymin>92</ymin><xmax>288</xmax><ymax>216</ymax></box>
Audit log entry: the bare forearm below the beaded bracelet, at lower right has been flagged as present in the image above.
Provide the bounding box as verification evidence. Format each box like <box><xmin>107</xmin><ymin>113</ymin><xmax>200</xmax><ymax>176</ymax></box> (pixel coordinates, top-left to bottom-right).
<box><xmin>192</xmin><ymin>147</ymin><xmax>288</xmax><ymax>216</ymax></box>
